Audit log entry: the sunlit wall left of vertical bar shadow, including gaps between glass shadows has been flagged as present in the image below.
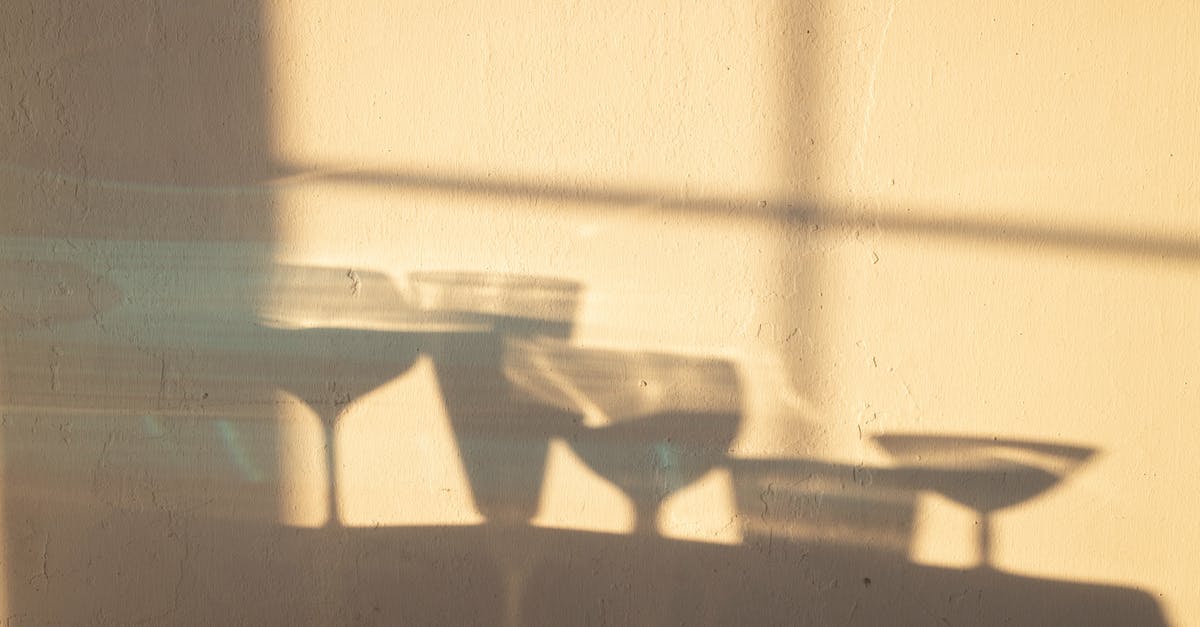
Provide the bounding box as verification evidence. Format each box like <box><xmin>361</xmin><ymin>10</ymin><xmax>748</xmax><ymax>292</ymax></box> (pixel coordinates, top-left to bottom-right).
<box><xmin>271</xmin><ymin>2</ymin><xmax>781</xmax><ymax>542</ymax></box>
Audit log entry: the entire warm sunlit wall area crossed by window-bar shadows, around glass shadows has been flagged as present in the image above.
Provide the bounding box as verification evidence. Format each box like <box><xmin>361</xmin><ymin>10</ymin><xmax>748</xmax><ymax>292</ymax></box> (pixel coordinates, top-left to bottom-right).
<box><xmin>258</xmin><ymin>1</ymin><xmax>1200</xmax><ymax>621</ymax></box>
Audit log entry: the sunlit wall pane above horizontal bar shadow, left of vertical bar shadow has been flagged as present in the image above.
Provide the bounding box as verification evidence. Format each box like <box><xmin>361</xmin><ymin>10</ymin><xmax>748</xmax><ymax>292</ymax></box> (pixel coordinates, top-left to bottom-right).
<box><xmin>272</xmin><ymin>1</ymin><xmax>776</xmax><ymax>196</ymax></box>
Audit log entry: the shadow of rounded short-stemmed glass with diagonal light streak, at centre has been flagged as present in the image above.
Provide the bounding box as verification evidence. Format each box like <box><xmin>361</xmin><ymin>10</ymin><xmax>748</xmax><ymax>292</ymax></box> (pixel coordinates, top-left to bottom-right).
<box><xmin>505</xmin><ymin>339</ymin><xmax>742</xmax><ymax>535</ymax></box>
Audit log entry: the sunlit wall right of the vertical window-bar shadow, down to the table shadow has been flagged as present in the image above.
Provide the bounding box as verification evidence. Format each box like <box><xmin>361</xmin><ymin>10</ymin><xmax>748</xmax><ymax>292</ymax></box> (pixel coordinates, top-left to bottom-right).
<box><xmin>768</xmin><ymin>1</ymin><xmax>1200</xmax><ymax>621</ymax></box>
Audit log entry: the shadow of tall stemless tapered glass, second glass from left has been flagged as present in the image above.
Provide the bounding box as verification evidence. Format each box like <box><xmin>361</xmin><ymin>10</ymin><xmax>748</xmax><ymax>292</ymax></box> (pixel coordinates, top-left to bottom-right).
<box><xmin>409</xmin><ymin>271</ymin><xmax>583</xmax><ymax>524</ymax></box>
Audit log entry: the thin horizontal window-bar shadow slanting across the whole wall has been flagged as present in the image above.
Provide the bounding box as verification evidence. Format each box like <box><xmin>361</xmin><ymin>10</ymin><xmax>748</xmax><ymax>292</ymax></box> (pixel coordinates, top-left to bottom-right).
<box><xmin>0</xmin><ymin>158</ymin><xmax>1200</xmax><ymax>263</ymax></box>
